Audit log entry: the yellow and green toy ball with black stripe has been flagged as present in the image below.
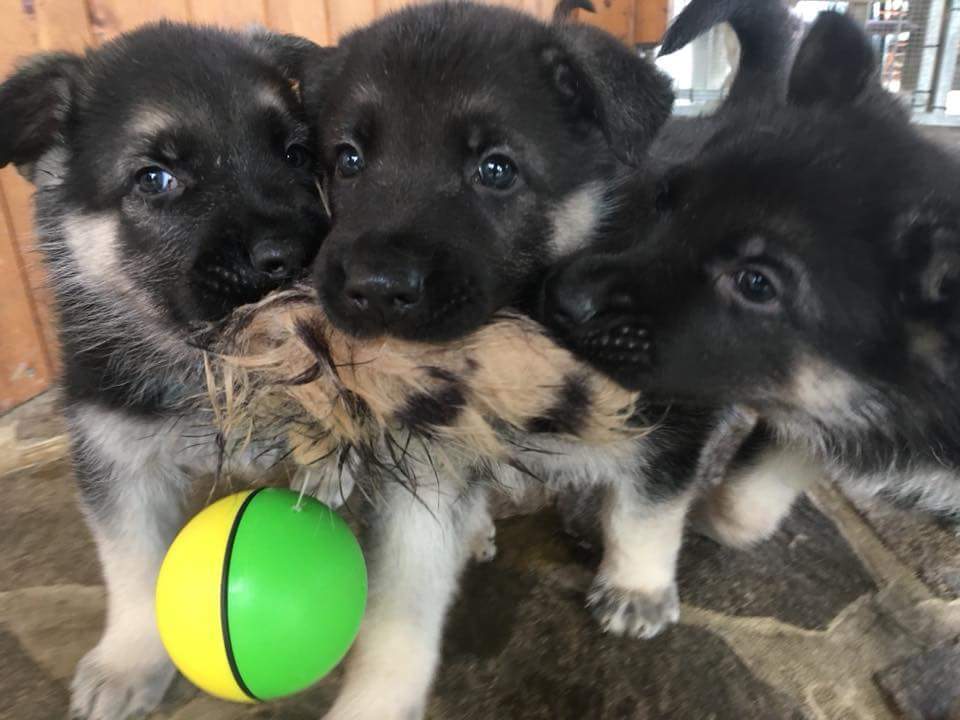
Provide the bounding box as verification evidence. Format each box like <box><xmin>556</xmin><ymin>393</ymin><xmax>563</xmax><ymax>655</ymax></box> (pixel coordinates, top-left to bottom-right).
<box><xmin>157</xmin><ymin>488</ymin><xmax>367</xmax><ymax>702</ymax></box>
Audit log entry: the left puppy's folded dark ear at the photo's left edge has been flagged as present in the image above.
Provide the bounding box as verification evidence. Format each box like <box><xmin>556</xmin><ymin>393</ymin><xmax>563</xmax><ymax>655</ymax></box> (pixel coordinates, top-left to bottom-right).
<box><xmin>0</xmin><ymin>53</ymin><xmax>83</xmax><ymax>170</ymax></box>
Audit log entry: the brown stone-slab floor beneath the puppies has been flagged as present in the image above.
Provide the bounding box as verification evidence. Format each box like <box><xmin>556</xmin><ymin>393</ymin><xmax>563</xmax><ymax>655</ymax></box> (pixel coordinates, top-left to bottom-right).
<box><xmin>0</xmin><ymin>390</ymin><xmax>960</xmax><ymax>720</ymax></box>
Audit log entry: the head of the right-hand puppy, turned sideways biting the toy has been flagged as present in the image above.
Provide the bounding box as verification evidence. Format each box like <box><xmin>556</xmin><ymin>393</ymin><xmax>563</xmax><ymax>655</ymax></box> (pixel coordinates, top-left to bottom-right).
<box><xmin>544</xmin><ymin>14</ymin><xmax>960</xmax><ymax>416</ymax></box>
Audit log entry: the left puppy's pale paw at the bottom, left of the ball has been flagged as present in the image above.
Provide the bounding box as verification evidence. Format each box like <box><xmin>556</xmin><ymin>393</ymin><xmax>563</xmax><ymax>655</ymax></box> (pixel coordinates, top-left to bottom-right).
<box><xmin>70</xmin><ymin>647</ymin><xmax>176</xmax><ymax>720</ymax></box>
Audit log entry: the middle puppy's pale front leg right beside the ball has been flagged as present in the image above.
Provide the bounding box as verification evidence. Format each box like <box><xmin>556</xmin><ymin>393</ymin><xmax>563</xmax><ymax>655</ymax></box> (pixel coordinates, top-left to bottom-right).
<box><xmin>326</xmin><ymin>481</ymin><xmax>489</xmax><ymax>720</ymax></box>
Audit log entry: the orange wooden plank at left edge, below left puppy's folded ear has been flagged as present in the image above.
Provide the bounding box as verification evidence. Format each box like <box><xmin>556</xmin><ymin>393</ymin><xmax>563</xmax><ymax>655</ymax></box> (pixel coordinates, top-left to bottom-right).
<box><xmin>0</xmin><ymin>183</ymin><xmax>53</xmax><ymax>413</ymax></box>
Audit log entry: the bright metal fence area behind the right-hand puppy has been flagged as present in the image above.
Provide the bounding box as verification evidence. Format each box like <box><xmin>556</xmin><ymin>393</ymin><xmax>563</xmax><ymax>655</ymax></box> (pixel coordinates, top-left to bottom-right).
<box><xmin>658</xmin><ymin>0</ymin><xmax>960</xmax><ymax>124</ymax></box>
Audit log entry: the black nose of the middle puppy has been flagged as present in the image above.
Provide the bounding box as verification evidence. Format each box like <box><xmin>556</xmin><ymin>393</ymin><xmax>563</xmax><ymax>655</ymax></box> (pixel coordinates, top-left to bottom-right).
<box><xmin>343</xmin><ymin>262</ymin><xmax>424</xmax><ymax>319</ymax></box>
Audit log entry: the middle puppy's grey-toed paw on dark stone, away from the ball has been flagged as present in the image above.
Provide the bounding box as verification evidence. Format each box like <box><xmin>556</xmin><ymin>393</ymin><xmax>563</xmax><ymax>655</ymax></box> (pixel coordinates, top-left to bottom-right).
<box><xmin>587</xmin><ymin>577</ymin><xmax>680</xmax><ymax>638</ymax></box>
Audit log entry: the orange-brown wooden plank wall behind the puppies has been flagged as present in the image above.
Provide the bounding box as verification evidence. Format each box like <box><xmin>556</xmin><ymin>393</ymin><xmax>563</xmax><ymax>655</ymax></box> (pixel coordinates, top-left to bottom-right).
<box><xmin>0</xmin><ymin>0</ymin><xmax>668</xmax><ymax>413</ymax></box>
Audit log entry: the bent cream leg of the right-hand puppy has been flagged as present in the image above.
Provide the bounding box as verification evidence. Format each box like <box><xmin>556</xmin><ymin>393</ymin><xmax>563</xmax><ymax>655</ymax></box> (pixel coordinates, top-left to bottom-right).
<box><xmin>694</xmin><ymin>445</ymin><xmax>824</xmax><ymax>548</ymax></box>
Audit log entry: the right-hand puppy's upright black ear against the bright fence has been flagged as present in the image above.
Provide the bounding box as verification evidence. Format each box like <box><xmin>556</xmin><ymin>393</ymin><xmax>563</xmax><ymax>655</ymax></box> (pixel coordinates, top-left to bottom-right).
<box><xmin>787</xmin><ymin>12</ymin><xmax>880</xmax><ymax>105</ymax></box>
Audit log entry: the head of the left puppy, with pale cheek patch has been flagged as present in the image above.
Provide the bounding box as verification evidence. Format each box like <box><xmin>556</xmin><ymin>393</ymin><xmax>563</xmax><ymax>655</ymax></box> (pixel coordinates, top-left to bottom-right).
<box><xmin>0</xmin><ymin>23</ymin><xmax>327</xmax><ymax>326</ymax></box>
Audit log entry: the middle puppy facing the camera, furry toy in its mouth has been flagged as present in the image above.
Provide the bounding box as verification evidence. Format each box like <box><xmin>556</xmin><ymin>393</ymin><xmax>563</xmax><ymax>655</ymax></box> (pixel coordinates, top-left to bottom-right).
<box><xmin>303</xmin><ymin>3</ymin><xmax>676</xmax><ymax>720</ymax></box>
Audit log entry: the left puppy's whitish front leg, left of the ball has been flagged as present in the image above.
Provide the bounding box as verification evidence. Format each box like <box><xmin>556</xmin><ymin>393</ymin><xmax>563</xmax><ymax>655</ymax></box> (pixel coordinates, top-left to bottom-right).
<box><xmin>70</xmin><ymin>411</ymin><xmax>185</xmax><ymax>720</ymax></box>
